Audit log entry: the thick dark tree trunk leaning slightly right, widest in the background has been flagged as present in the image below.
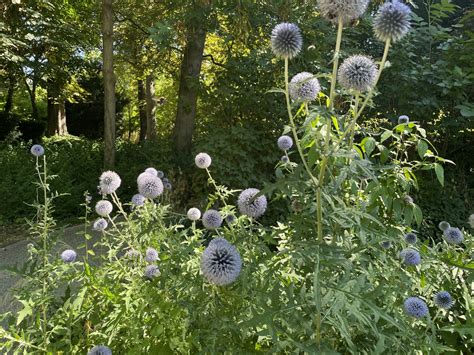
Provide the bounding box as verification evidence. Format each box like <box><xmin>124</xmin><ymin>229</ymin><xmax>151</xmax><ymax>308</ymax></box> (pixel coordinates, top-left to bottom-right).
<box><xmin>174</xmin><ymin>20</ymin><xmax>206</xmax><ymax>157</ymax></box>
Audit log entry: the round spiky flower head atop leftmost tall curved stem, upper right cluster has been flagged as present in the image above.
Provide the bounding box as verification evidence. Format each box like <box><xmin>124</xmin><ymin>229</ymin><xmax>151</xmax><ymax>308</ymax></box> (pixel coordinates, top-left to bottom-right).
<box><xmin>270</xmin><ymin>22</ymin><xmax>303</xmax><ymax>59</ymax></box>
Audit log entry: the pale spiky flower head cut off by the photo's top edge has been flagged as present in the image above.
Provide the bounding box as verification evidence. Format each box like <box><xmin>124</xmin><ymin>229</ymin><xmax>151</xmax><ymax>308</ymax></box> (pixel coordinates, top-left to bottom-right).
<box><xmin>318</xmin><ymin>0</ymin><xmax>369</xmax><ymax>24</ymax></box>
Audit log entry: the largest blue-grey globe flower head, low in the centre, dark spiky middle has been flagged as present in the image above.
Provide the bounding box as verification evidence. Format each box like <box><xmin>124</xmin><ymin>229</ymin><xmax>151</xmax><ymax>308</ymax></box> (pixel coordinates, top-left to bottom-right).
<box><xmin>201</xmin><ymin>238</ymin><xmax>242</xmax><ymax>286</ymax></box>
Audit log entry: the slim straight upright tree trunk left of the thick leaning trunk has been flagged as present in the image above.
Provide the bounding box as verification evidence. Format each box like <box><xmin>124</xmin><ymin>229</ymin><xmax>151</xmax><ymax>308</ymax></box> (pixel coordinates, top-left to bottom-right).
<box><xmin>102</xmin><ymin>0</ymin><xmax>115</xmax><ymax>169</ymax></box>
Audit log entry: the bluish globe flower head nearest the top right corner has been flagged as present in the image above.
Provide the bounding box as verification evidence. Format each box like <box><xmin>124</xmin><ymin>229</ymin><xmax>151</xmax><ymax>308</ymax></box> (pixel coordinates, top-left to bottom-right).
<box><xmin>374</xmin><ymin>0</ymin><xmax>411</xmax><ymax>42</ymax></box>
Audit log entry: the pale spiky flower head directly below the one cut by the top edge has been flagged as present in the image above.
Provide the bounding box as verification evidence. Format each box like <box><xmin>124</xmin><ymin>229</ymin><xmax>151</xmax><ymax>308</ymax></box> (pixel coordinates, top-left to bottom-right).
<box><xmin>338</xmin><ymin>55</ymin><xmax>377</xmax><ymax>92</ymax></box>
